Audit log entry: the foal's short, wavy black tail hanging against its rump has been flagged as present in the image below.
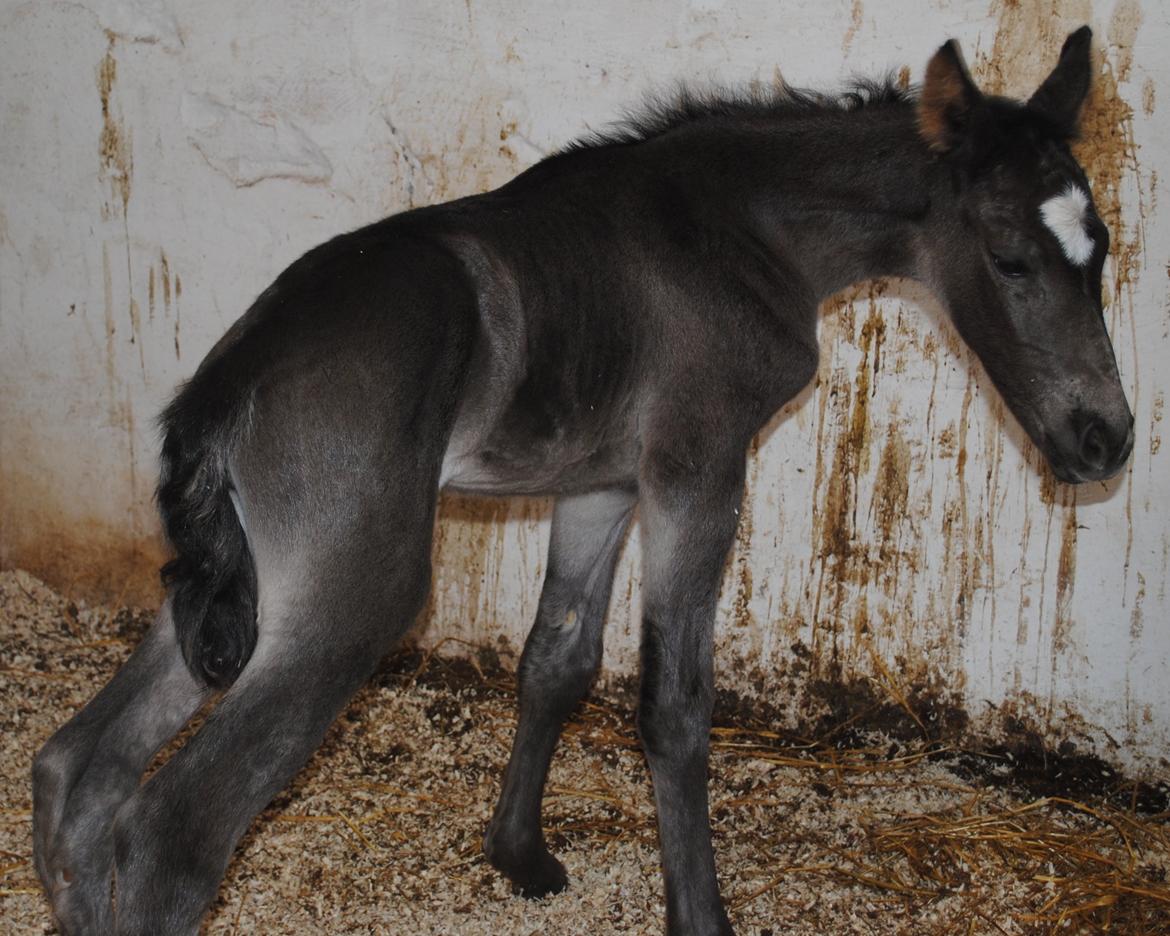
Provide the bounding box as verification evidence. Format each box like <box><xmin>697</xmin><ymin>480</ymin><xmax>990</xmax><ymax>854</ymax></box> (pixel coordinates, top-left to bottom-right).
<box><xmin>158</xmin><ymin>374</ymin><xmax>256</xmax><ymax>688</ymax></box>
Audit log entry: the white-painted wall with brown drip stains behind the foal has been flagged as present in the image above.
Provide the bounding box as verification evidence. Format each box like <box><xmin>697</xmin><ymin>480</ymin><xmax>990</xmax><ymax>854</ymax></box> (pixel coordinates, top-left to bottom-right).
<box><xmin>0</xmin><ymin>0</ymin><xmax>1170</xmax><ymax>768</ymax></box>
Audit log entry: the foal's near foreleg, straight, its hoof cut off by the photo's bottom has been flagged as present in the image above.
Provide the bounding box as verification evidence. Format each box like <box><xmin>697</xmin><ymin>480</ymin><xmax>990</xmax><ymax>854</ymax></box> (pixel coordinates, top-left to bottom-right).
<box><xmin>638</xmin><ymin>444</ymin><xmax>743</xmax><ymax>936</ymax></box>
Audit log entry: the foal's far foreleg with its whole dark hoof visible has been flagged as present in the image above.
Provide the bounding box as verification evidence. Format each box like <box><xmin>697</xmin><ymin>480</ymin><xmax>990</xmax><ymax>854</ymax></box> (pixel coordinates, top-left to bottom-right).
<box><xmin>483</xmin><ymin>490</ymin><xmax>635</xmax><ymax>897</ymax></box>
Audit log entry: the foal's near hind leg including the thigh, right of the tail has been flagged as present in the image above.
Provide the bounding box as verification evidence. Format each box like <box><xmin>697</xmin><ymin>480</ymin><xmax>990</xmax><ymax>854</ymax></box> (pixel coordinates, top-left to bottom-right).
<box><xmin>105</xmin><ymin>327</ymin><xmax>459</xmax><ymax>936</ymax></box>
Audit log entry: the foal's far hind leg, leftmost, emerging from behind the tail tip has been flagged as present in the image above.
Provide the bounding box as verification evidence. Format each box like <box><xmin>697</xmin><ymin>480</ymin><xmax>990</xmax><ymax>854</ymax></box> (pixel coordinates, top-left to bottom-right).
<box><xmin>33</xmin><ymin>600</ymin><xmax>209</xmax><ymax>934</ymax></box>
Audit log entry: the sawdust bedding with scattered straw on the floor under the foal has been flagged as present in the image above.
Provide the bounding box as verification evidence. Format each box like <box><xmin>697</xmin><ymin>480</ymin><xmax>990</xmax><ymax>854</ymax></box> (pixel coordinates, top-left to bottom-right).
<box><xmin>0</xmin><ymin>572</ymin><xmax>1170</xmax><ymax>936</ymax></box>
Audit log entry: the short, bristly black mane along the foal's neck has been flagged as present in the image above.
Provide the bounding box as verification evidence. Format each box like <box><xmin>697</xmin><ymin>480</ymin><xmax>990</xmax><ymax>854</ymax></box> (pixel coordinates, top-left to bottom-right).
<box><xmin>562</xmin><ymin>75</ymin><xmax>917</xmax><ymax>153</ymax></box>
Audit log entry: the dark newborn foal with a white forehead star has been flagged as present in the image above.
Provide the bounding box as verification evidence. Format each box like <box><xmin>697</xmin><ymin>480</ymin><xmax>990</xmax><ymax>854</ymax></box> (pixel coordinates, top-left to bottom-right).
<box><xmin>34</xmin><ymin>28</ymin><xmax>1133</xmax><ymax>934</ymax></box>
